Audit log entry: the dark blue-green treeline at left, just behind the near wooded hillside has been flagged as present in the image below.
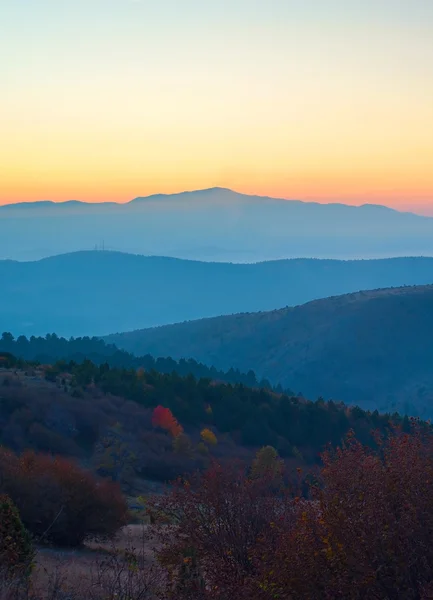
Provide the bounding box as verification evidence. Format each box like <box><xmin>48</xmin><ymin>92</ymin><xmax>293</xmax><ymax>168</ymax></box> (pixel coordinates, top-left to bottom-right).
<box><xmin>0</xmin><ymin>332</ymin><xmax>284</xmax><ymax>394</ymax></box>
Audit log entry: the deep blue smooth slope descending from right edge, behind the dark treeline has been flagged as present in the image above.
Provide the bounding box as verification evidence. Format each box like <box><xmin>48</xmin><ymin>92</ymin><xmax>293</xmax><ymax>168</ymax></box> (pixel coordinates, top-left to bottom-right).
<box><xmin>107</xmin><ymin>286</ymin><xmax>433</xmax><ymax>417</ymax></box>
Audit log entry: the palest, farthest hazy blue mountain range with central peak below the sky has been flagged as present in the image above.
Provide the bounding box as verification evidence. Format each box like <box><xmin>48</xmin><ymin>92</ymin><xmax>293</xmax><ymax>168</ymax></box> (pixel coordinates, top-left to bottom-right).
<box><xmin>0</xmin><ymin>188</ymin><xmax>433</xmax><ymax>262</ymax></box>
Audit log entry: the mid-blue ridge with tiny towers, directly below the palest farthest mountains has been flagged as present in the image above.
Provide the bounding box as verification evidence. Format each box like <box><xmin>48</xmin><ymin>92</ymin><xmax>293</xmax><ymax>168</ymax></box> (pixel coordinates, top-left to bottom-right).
<box><xmin>0</xmin><ymin>251</ymin><xmax>433</xmax><ymax>338</ymax></box>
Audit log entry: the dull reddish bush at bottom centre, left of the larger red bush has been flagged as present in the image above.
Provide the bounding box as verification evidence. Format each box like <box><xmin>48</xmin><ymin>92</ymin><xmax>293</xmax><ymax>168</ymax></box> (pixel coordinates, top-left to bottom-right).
<box><xmin>150</xmin><ymin>462</ymin><xmax>282</xmax><ymax>599</ymax></box>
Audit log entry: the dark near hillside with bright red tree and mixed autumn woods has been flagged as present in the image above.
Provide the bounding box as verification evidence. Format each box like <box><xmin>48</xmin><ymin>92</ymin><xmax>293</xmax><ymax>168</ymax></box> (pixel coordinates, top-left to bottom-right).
<box><xmin>0</xmin><ymin>353</ymin><xmax>409</xmax><ymax>485</ymax></box>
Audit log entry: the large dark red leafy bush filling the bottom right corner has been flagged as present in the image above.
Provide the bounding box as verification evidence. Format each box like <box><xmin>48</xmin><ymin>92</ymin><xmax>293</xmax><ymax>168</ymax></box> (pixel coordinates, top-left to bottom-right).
<box><xmin>251</xmin><ymin>423</ymin><xmax>433</xmax><ymax>600</ymax></box>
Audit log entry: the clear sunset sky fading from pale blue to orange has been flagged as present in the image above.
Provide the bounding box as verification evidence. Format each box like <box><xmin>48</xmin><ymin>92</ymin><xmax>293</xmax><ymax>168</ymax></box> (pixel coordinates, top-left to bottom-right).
<box><xmin>0</xmin><ymin>0</ymin><xmax>433</xmax><ymax>215</ymax></box>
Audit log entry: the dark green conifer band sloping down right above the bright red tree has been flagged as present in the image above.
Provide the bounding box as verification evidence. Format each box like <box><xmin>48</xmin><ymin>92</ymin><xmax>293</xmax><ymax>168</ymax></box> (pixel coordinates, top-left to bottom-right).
<box><xmin>14</xmin><ymin>352</ymin><xmax>409</xmax><ymax>462</ymax></box>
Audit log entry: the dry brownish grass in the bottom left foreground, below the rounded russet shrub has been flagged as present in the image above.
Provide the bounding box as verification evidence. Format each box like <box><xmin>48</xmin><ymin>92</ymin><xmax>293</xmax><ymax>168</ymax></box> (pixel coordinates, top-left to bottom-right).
<box><xmin>0</xmin><ymin>525</ymin><xmax>164</xmax><ymax>600</ymax></box>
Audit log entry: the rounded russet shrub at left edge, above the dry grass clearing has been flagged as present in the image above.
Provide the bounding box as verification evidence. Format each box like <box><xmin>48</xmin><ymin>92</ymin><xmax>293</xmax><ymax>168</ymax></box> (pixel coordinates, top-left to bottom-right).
<box><xmin>0</xmin><ymin>449</ymin><xmax>127</xmax><ymax>546</ymax></box>
